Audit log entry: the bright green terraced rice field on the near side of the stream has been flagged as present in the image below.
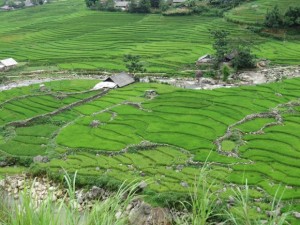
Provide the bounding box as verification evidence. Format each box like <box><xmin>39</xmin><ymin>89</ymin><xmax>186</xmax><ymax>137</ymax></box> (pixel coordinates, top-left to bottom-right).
<box><xmin>0</xmin><ymin>78</ymin><xmax>300</xmax><ymax>219</ymax></box>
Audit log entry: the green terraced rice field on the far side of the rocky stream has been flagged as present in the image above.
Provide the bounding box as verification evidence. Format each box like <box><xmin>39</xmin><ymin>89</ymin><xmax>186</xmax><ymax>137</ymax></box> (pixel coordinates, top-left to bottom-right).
<box><xmin>0</xmin><ymin>0</ymin><xmax>300</xmax><ymax>74</ymax></box>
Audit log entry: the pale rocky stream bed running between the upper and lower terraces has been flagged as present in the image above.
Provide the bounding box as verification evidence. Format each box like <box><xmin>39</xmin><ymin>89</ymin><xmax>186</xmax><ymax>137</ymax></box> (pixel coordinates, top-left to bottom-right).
<box><xmin>0</xmin><ymin>66</ymin><xmax>300</xmax><ymax>91</ymax></box>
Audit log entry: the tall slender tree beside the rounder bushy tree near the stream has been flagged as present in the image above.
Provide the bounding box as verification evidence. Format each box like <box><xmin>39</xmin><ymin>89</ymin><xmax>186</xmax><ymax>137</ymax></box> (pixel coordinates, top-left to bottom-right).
<box><xmin>210</xmin><ymin>30</ymin><xmax>229</xmax><ymax>67</ymax></box>
